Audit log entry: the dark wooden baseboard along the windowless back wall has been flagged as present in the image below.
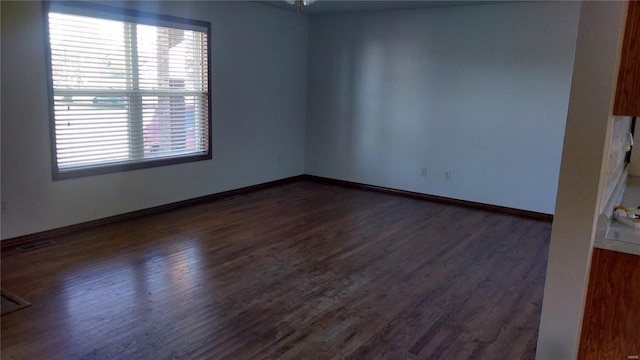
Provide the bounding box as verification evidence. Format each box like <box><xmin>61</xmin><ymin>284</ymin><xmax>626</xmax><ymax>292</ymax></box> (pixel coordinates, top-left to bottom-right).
<box><xmin>302</xmin><ymin>175</ymin><xmax>553</xmax><ymax>221</ymax></box>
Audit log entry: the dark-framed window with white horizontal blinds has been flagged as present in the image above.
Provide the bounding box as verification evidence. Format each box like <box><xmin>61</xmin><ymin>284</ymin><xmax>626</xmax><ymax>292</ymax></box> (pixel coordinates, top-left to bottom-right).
<box><xmin>44</xmin><ymin>2</ymin><xmax>211</xmax><ymax>179</ymax></box>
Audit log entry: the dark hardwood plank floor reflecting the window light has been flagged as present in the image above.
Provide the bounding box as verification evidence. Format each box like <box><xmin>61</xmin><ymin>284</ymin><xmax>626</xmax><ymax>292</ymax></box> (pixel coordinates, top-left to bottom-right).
<box><xmin>1</xmin><ymin>181</ymin><xmax>551</xmax><ymax>360</ymax></box>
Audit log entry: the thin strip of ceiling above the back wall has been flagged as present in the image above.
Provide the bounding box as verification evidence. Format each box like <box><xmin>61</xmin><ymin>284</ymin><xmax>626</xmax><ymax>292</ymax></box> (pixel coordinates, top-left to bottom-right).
<box><xmin>255</xmin><ymin>0</ymin><xmax>505</xmax><ymax>14</ymax></box>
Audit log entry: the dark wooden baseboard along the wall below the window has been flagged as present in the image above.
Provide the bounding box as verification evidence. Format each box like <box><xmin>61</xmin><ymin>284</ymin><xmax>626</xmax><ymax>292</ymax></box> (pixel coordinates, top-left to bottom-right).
<box><xmin>0</xmin><ymin>175</ymin><xmax>304</xmax><ymax>251</ymax></box>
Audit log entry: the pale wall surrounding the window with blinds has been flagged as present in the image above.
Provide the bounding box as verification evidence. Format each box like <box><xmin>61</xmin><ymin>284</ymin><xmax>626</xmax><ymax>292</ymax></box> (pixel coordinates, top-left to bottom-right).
<box><xmin>1</xmin><ymin>1</ymin><xmax>308</xmax><ymax>239</ymax></box>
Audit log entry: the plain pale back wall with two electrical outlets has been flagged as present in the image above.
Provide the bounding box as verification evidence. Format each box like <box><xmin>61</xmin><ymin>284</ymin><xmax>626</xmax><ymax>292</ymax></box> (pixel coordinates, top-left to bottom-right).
<box><xmin>306</xmin><ymin>2</ymin><xmax>580</xmax><ymax>213</ymax></box>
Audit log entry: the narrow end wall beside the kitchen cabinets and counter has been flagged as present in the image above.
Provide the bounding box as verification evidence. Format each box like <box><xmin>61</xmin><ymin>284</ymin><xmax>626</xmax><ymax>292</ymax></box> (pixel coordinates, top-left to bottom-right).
<box><xmin>536</xmin><ymin>1</ymin><xmax>625</xmax><ymax>360</ymax></box>
